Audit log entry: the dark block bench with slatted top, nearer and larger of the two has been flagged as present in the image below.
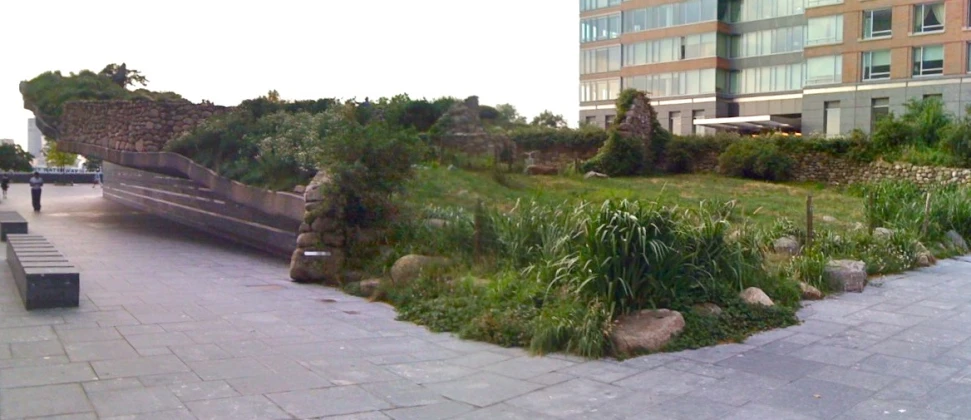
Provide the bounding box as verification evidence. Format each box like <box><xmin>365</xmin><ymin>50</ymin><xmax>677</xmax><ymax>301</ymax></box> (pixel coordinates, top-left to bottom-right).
<box><xmin>7</xmin><ymin>233</ymin><xmax>81</xmax><ymax>310</ymax></box>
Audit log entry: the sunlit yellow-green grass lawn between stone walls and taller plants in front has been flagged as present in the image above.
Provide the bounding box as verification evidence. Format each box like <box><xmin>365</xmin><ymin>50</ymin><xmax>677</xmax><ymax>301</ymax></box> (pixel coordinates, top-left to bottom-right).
<box><xmin>408</xmin><ymin>168</ymin><xmax>864</xmax><ymax>229</ymax></box>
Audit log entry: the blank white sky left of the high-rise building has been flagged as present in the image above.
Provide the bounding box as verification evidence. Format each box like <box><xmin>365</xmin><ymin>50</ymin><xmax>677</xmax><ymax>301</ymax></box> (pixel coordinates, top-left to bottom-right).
<box><xmin>0</xmin><ymin>0</ymin><xmax>579</xmax><ymax>149</ymax></box>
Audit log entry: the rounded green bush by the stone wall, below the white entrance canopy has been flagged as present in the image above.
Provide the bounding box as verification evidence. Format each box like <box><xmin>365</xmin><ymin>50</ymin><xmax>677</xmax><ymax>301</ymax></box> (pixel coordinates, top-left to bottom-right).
<box><xmin>718</xmin><ymin>139</ymin><xmax>794</xmax><ymax>181</ymax></box>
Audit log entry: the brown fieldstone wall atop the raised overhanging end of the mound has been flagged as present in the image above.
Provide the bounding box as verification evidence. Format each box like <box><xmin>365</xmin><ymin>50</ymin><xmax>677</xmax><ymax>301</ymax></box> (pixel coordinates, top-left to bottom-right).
<box><xmin>59</xmin><ymin>100</ymin><xmax>231</xmax><ymax>152</ymax></box>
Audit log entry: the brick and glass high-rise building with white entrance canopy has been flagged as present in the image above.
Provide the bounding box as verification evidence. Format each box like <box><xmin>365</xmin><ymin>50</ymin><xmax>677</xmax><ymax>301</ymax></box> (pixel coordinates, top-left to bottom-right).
<box><xmin>580</xmin><ymin>0</ymin><xmax>971</xmax><ymax>135</ymax></box>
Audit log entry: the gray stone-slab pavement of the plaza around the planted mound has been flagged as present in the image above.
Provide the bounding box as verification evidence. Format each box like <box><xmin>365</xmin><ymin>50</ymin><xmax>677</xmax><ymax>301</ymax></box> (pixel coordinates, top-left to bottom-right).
<box><xmin>0</xmin><ymin>185</ymin><xmax>971</xmax><ymax>420</ymax></box>
